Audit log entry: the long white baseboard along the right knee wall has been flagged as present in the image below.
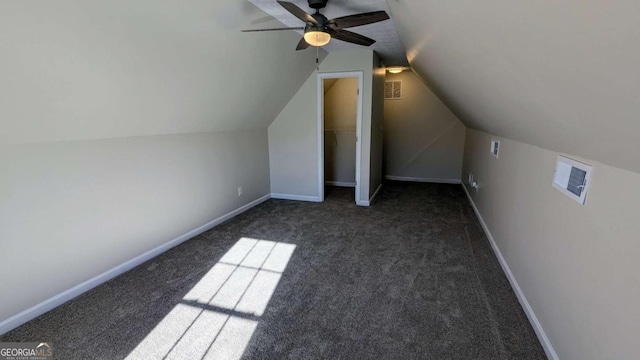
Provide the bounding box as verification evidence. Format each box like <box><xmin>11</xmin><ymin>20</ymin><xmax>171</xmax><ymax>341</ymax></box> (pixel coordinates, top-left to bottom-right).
<box><xmin>462</xmin><ymin>184</ymin><xmax>558</xmax><ymax>360</ymax></box>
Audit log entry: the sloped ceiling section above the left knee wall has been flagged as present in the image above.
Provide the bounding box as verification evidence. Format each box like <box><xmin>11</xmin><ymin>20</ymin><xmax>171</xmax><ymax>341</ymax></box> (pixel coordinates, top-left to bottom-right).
<box><xmin>0</xmin><ymin>0</ymin><xmax>325</xmax><ymax>144</ymax></box>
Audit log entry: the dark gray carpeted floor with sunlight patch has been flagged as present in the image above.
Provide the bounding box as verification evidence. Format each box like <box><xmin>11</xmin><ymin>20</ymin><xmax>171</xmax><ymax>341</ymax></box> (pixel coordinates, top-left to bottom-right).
<box><xmin>0</xmin><ymin>182</ymin><xmax>545</xmax><ymax>359</ymax></box>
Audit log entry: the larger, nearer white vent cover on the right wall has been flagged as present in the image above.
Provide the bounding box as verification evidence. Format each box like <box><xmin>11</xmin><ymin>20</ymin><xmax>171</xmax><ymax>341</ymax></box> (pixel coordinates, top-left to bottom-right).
<box><xmin>553</xmin><ymin>156</ymin><xmax>593</xmax><ymax>205</ymax></box>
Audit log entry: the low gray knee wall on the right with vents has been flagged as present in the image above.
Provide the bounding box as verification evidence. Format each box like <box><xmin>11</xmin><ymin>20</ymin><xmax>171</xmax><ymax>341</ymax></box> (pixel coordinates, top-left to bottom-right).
<box><xmin>463</xmin><ymin>129</ymin><xmax>640</xmax><ymax>359</ymax></box>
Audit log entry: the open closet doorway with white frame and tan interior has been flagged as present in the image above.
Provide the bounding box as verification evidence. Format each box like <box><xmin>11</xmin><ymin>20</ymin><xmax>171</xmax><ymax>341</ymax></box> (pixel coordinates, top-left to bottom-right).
<box><xmin>318</xmin><ymin>72</ymin><xmax>362</xmax><ymax>203</ymax></box>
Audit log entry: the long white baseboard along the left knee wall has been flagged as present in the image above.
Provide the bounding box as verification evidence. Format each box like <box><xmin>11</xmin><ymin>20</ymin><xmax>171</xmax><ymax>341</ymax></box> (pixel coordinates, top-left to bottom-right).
<box><xmin>0</xmin><ymin>194</ymin><xmax>271</xmax><ymax>335</ymax></box>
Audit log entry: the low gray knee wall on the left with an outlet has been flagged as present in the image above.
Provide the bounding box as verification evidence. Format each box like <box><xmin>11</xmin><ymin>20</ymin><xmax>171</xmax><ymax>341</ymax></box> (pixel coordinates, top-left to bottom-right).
<box><xmin>0</xmin><ymin>129</ymin><xmax>269</xmax><ymax>320</ymax></box>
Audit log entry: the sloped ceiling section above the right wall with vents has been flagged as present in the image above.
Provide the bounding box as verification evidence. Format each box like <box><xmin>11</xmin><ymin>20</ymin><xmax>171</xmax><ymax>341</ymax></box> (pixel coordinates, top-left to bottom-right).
<box><xmin>388</xmin><ymin>0</ymin><xmax>640</xmax><ymax>172</ymax></box>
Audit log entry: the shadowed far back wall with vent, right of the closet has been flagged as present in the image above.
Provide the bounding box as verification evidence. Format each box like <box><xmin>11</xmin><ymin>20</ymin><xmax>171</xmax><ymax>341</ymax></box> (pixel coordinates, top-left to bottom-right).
<box><xmin>384</xmin><ymin>71</ymin><xmax>466</xmax><ymax>182</ymax></box>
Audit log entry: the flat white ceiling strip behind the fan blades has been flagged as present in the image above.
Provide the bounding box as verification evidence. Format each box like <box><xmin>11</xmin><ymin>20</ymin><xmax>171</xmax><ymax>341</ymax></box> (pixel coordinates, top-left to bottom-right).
<box><xmin>249</xmin><ymin>0</ymin><xmax>409</xmax><ymax>66</ymax></box>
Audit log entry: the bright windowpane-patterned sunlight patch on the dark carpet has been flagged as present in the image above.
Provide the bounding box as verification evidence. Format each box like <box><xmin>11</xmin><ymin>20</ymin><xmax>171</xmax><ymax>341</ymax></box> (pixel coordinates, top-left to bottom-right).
<box><xmin>127</xmin><ymin>238</ymin><xmax>296</xmax><ymax>359</ymax></box>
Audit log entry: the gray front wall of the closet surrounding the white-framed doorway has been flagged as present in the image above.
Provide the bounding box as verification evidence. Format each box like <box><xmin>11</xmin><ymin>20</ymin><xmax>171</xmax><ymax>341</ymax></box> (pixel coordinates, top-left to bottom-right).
<box><xmin>269</xmin><ymin>49</ymin><xmax>373</xmax><ymax>201</ymax></box>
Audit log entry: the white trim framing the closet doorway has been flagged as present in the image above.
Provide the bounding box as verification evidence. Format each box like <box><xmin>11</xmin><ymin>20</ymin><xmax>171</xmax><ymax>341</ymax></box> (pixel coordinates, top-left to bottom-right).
<box><xmin>318</xmin><ymin>71</ymin><xmax>364</xmax><ymax>203</ymax></box>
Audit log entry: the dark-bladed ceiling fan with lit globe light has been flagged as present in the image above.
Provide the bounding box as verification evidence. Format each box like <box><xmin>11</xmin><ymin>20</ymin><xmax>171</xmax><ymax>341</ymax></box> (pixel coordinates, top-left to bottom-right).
<box><xmin>242</xmin><ymin>0</ymin><xmax>389</xmax><ymax>50</ymax></box>
